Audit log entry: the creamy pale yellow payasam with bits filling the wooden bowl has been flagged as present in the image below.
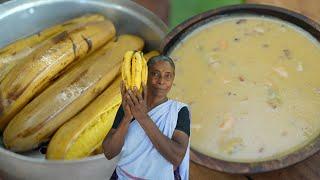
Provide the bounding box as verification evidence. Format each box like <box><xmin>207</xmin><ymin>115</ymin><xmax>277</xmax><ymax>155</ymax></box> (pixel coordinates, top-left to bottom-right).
<box><xmin>169</xmin><ymin>15</ymin><xmax>320</xmax><ymax>162</ymax></box>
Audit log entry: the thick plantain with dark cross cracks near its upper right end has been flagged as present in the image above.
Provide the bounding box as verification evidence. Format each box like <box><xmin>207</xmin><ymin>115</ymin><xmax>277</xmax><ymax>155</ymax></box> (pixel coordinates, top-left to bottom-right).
<box><xmin>0</xmin><ymin>20</ymin><xmax>115</xmax><ymax>131</ymax></box>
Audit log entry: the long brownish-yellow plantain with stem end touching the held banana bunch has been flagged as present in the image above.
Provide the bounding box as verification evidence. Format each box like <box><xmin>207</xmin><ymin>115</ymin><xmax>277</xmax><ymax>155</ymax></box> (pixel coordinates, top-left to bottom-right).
<box><xmin>3</xmin><ymin>35</ymin><xmax>144</xmax><ymax>152</ymax></box>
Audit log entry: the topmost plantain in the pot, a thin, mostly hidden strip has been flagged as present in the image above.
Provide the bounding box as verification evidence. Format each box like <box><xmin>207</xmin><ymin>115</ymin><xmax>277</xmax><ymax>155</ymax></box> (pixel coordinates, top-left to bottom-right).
<box><xmin>0</xmin><ymin>14</ymin><xmax>104</xmax><ymax>82</ymax></box>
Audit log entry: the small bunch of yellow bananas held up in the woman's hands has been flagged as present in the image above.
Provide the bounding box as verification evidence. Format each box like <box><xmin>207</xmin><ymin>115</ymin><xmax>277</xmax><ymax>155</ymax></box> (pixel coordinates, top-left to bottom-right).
<box><xmin>121</xmin><ymin>51</ymin><xmax>148</xmax><ymax>92</ymax></box>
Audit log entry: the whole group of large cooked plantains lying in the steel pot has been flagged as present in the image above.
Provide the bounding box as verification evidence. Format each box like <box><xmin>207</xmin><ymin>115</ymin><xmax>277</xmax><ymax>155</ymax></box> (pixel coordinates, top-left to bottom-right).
<box><xmin>0</xmin><ymin>14</ymin><xmax>157</xmax><ymax>159</ymax></box>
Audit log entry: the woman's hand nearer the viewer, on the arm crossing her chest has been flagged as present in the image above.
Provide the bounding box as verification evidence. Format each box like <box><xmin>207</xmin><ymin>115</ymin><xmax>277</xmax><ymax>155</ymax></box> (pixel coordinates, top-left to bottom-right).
<box><xmin>126</xmin><ymin>85</ymin><xmax>148</xmax><ymax>120</ymax></box>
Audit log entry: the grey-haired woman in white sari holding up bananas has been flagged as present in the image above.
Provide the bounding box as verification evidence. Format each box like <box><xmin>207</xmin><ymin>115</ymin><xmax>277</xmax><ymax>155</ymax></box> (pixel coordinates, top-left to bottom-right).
<box><xmin>103</xmin><ymin>55</ymin><xmax>190</xmax><ymax>180</ymax></box>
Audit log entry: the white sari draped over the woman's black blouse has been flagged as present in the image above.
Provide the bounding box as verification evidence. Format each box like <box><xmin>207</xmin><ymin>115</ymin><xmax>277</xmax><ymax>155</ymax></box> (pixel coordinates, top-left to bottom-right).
<box><xmin>116</xmin><ymin>100</ymin><xmax>190</xmax><ymax>180</ymax></box>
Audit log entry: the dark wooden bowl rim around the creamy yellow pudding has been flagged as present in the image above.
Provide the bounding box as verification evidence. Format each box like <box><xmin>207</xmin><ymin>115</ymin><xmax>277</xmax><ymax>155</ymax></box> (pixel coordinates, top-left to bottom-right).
<box><xmin>161</xmin><ymin>4</ymin><xmax>320</xmax><ymax>174</ymax></box>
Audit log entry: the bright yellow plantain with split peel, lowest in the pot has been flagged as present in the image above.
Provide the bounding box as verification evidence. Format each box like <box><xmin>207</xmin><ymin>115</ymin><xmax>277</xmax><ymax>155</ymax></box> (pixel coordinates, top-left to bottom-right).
<box><xmin>46</xmin><ymin>77</ymin><xmax>121</xmax><ymax>159</ymax></box>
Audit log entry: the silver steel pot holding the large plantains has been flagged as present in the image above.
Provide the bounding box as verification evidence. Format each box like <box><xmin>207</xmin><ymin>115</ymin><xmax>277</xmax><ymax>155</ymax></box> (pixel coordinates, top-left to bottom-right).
<box><xmin>0</xmin><ymin>0</ymin><xmax>167</xmax><ymax>180</ymax></box>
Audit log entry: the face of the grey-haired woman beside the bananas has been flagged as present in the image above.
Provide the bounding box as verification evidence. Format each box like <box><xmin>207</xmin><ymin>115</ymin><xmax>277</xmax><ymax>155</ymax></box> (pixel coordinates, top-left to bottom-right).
<box><xmin>148</xmin><ymin>61</ymin><xmax>174</xmax><ymax>97</ymax></box>
